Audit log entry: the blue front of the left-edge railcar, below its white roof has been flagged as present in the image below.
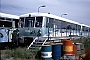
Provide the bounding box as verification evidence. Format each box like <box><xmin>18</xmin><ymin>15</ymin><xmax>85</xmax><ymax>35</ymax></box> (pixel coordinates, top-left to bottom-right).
<box><xmin>0</xmin><ymin>20</ymin><xmax>15</xmax><ymax>46</ymax></box>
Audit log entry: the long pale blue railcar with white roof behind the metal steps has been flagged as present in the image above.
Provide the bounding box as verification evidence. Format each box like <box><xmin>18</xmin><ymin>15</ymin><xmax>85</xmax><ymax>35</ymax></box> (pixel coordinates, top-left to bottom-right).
<box><xmin>15</xmin><ymin>12</ymin><xmax>90</xmax><ymax>43</ymax></box>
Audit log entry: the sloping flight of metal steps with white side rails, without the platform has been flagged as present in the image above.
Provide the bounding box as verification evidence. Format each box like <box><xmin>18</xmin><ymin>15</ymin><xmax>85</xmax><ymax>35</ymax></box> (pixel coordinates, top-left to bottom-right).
<box><xmin>28</xmin><ymin>37</ymin><xmax>48</xmax><ymax>51</ymax></box>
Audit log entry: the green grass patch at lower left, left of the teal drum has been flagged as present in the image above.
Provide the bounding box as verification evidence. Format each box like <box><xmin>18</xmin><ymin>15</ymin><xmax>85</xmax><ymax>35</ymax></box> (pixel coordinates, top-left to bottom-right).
<box><xmin>1</xmin><ymin>47</ymin><xmax>41</xmax><ymax>60</ymax></box>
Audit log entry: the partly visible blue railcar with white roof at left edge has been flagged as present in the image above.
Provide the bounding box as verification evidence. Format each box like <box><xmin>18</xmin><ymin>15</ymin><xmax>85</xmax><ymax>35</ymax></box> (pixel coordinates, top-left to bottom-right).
<box><xmin>0</xmin><ymin>12</ymin><xmax>19</xmax><ymax>45</ymax></box>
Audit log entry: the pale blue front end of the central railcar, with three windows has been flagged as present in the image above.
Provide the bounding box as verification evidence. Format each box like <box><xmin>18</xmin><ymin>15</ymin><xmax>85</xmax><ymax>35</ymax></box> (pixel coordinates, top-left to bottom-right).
<box><xmin>18</xmin><ymin>15</ymin><xmax>45</xmax><ymax>44</ymax></box>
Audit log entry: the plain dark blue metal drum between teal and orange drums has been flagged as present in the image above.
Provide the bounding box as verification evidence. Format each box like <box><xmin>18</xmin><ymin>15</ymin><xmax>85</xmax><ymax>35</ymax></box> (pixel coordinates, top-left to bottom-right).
<box><xmin>52</xmin><ymin>44</ymin><xmax>62</xmax><ymax>60</ymax></box>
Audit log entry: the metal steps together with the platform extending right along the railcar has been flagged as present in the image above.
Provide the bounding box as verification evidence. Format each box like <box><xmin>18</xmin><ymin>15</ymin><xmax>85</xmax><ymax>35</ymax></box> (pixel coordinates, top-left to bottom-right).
<box><xmin>27</xmin><ymin>37</ymin><xmax>79</xmax><ymax>51</ymax></box>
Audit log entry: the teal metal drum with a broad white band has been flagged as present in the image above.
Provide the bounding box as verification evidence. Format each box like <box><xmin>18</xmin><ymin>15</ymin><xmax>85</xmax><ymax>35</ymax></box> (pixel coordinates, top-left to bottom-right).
<box><xmin>41</xmin><ymin>45</ymin><xmax>52</xmax><ymax>60</ymax></box>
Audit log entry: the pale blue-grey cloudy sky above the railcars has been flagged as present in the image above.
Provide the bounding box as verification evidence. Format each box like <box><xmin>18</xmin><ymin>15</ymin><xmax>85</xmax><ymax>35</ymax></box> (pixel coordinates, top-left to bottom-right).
<box><xmin>0</xmin><ymin>0</ymin><xmax>90</xmax><ymax>26</ymax></box>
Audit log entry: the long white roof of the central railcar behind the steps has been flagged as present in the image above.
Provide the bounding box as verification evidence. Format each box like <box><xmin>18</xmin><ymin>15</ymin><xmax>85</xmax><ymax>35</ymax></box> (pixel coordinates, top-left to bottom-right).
<box><xmin>20</xmin><ymin>12</ymin><xmax>80</xmax><ymax>25</ymax></box>
